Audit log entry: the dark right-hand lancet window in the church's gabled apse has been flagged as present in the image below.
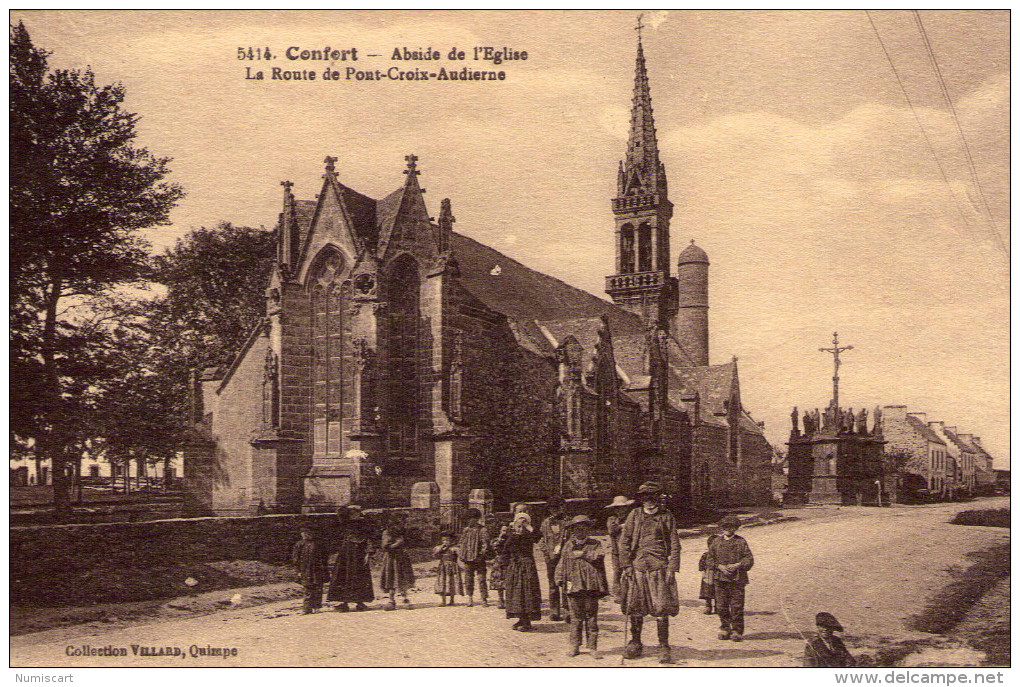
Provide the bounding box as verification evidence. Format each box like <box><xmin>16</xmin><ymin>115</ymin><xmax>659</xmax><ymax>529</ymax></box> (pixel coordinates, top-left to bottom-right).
<box><xmin>387</xmin><ymin>256</ymin><xmax>424</xmax><ymax>458</ymax></box>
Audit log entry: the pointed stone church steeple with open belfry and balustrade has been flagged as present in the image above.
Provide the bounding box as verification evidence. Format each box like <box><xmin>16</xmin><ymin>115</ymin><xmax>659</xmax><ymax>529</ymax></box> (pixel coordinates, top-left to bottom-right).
<box><xmin>606</xmin><ymin>22</ymin><xmax>676</xmax><ymax>327</ymax></box>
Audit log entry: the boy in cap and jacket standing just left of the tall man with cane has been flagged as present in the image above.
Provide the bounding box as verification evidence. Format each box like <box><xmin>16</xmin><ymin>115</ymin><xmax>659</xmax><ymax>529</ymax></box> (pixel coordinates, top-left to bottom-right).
<box><xmin>555</xmin><ymin>515</ymin><xmax>609</xmax><ymax>658</ymax></box>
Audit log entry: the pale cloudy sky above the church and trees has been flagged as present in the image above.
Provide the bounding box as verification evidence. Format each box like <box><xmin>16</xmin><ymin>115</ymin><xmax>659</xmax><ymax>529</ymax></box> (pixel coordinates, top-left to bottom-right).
<box><xmin>11</xmin><ymin>11</ymin><xmax>1010</xmax><ymax>467</ymax></box>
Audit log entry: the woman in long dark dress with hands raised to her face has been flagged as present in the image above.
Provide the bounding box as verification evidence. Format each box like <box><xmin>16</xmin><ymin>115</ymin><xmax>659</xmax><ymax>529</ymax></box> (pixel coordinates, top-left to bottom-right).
<box><xmin>502</xmin><ymin>505</ymin><xmax>542</xmax><ymax>632</ymax></box>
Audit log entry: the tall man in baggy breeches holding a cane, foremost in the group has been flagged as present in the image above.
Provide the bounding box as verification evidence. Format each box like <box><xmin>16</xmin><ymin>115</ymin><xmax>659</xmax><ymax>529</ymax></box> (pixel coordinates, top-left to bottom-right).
<box><xmin>620</xmin><ymin>482</ymin><xmax>680</xmax><ymax>664</ymax></box>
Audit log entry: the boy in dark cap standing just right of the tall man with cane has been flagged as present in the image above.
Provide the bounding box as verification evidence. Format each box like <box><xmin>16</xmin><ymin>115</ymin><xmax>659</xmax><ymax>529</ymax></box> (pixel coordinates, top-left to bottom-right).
<box><xmin>705</xmin><ymin>516</ymin><xmax>755</xmax><ymax>642</ymax></box>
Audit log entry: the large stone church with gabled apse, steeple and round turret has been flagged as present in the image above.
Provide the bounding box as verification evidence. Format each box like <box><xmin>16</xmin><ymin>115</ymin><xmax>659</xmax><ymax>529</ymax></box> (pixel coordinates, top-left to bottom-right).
<box><xmin>186</xmin><ymin>41</ymin><xmax>772</xmax><ymax>518</ymax></box>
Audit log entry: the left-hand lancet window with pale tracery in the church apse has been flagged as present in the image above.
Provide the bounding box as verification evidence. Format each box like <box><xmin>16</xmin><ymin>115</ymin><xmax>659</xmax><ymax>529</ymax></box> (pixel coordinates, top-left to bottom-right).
<box><xmin>309</xmin><ymin>253</ymin><xmax>344</xmax><ymax>458</ymax></box>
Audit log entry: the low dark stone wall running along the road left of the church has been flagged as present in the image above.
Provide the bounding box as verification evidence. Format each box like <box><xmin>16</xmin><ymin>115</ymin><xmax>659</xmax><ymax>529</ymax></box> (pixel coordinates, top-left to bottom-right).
<box><xmin>9</xmin><ymin>509</ymin><xmax>439</xmax><ymax>601</ymax></box>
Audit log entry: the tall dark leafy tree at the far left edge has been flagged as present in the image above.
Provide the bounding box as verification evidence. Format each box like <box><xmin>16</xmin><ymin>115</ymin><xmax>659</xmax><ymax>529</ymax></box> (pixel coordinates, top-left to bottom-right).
<box><xmin>10</xmin><ymin>23</ymin><xmax>183</xmax><ymax>511</ymax></box>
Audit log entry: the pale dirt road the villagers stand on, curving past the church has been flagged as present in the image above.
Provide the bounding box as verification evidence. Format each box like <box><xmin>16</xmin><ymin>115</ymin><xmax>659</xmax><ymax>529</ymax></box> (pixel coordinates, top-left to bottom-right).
<box><xmin>10</xmin><ymin>497</ymin><xmax>1009</xmax><ymax>667</ymax></box>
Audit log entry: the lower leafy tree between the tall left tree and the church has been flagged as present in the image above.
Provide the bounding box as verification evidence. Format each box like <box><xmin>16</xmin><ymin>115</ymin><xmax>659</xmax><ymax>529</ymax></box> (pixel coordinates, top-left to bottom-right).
<box><xmin>88</xmin><ymin>222</ymin><xmax>275</xmax><ymax>477</ymax></box>
